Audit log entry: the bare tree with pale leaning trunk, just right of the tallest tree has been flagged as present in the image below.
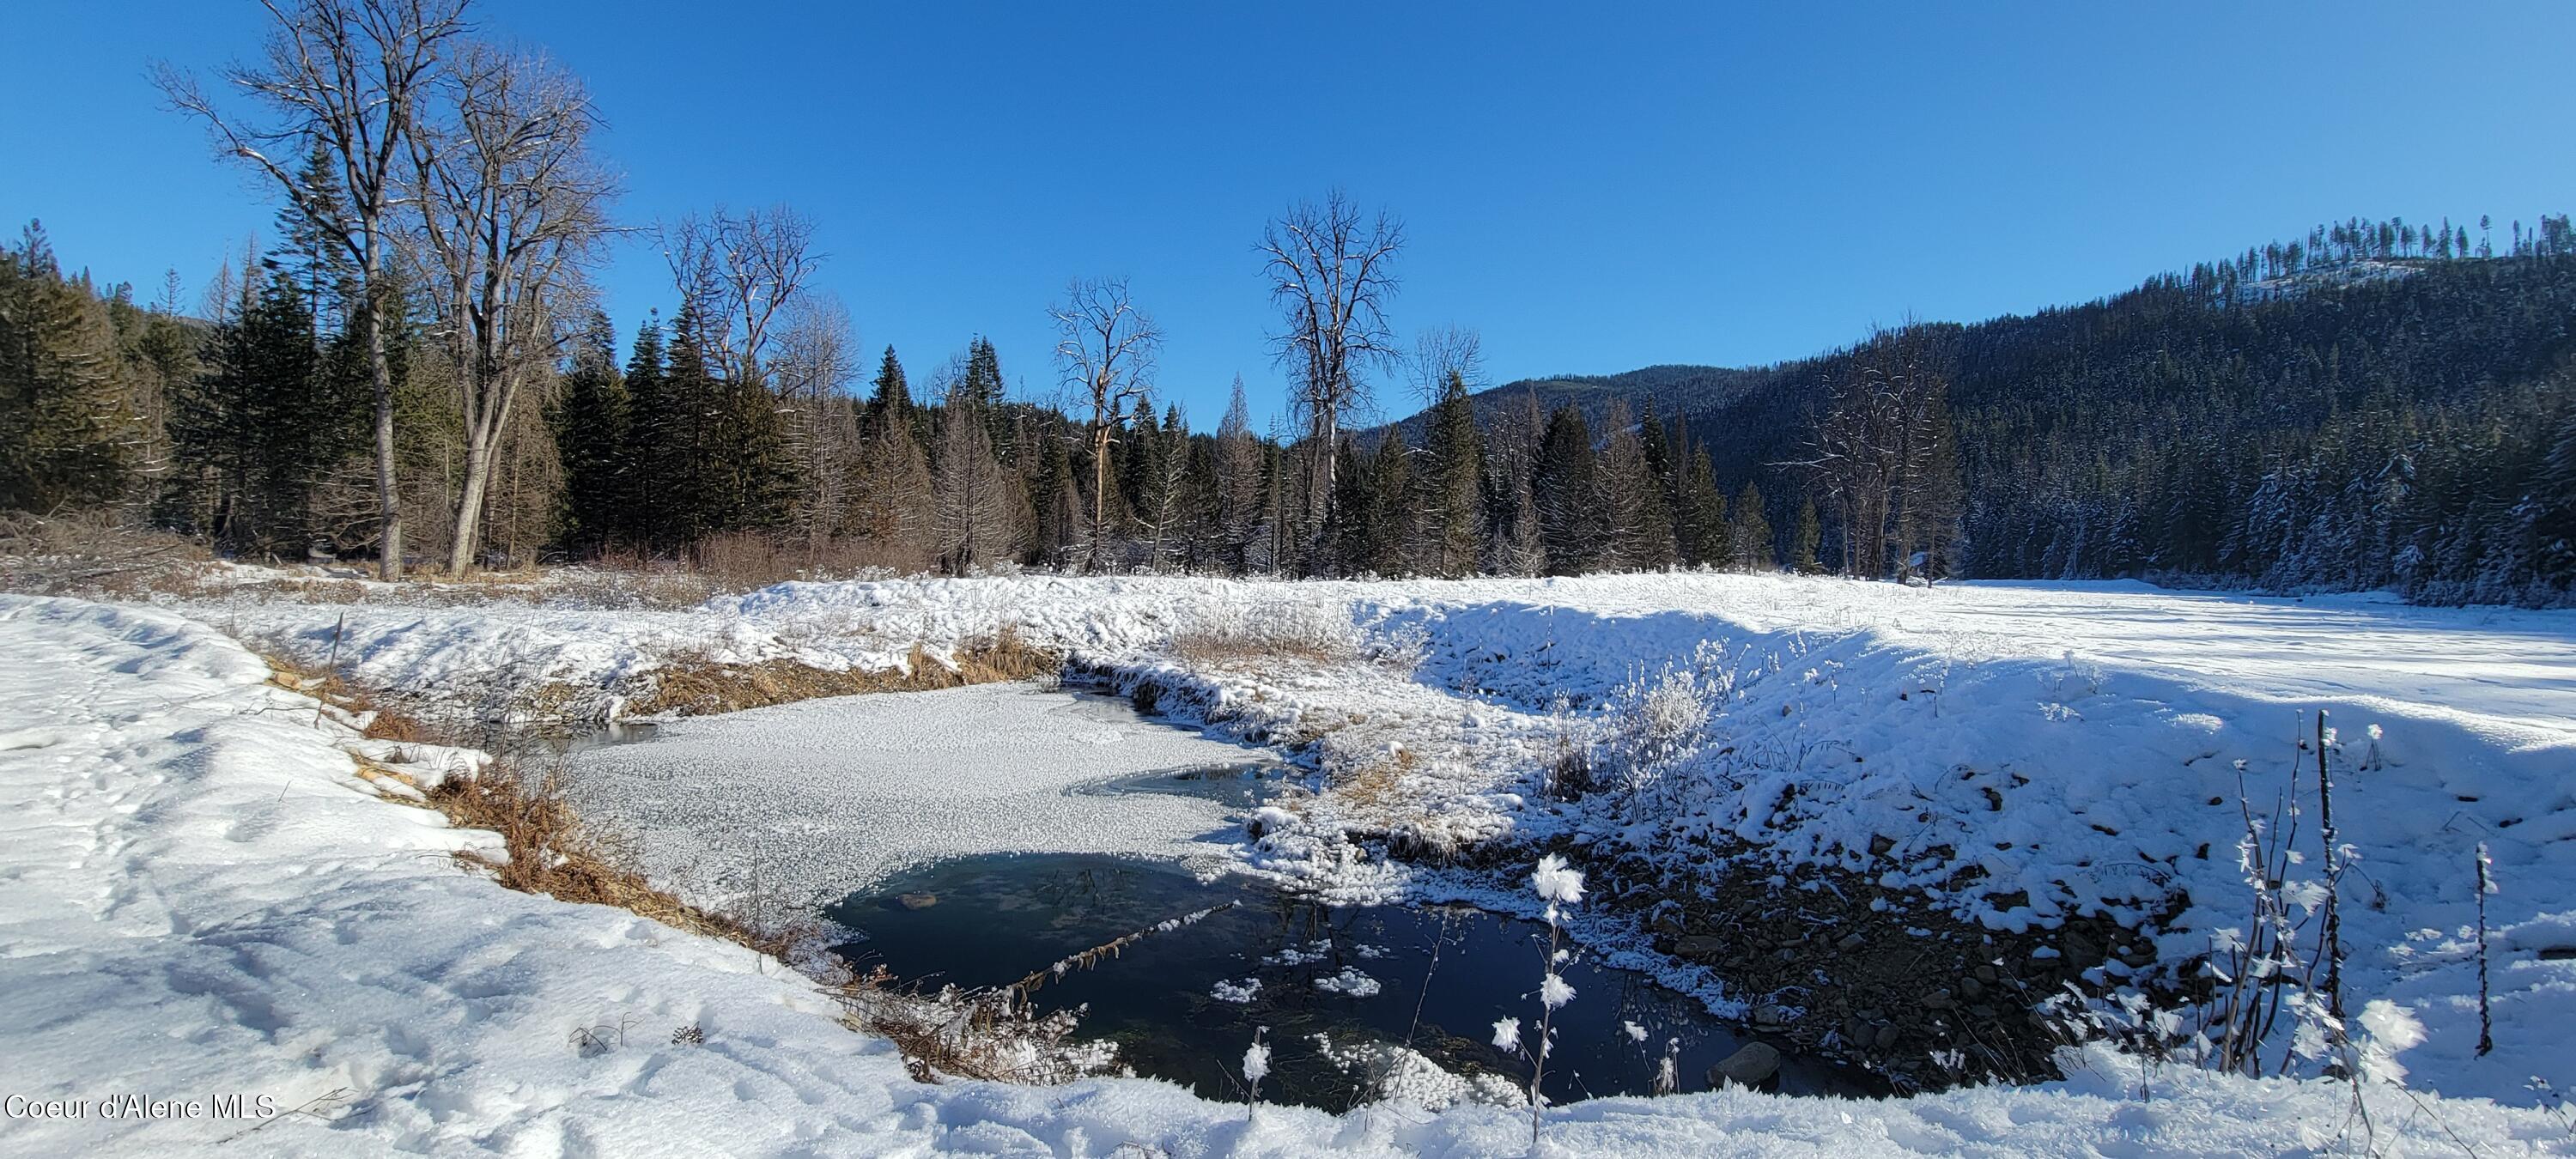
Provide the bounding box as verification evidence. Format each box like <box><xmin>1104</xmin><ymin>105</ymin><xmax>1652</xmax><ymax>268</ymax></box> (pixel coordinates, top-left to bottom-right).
<box><xmin>410</xmin><ymin>41</ymin><xmax>616</xmax><ymax>574</ymax></box>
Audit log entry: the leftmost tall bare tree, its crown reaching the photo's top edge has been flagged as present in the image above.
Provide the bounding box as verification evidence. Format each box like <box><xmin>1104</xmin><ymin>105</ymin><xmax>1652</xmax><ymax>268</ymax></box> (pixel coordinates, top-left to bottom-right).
<box><xmin>157</xmin><ymin>0</ymin><xmax>464</xmax><ymax>580</ymax></box>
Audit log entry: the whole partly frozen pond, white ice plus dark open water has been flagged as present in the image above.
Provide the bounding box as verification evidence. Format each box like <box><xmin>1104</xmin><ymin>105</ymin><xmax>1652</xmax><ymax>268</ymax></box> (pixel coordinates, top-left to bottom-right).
<box><xmin>567</xmin><ymin>685</ymin><xmax>1865</xmax><ymax>1107</ymax></box>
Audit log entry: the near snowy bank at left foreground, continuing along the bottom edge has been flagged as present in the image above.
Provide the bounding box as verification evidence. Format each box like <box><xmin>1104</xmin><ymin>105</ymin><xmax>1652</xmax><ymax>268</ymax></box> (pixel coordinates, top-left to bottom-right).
<box><xmin>0</xmin><ymin>598</ymin><xmax>2576</xmax><ymax>1156</ymax></box>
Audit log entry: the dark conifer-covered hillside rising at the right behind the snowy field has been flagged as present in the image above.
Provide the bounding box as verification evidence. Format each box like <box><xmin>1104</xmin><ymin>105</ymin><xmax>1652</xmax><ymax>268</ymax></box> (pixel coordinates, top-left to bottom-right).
<box><xmin>1476</xmin><ymin>216</ymin><xmax>2576</xmax><ymax>603</ymax></box>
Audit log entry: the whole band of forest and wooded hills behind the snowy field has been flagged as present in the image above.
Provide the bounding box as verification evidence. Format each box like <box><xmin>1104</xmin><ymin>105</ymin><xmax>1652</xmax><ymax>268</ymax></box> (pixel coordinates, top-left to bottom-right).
<box><xmin>0</xmin><ymin>191</ymin><xmax>2576</xmax><ymax>605</ymax></box>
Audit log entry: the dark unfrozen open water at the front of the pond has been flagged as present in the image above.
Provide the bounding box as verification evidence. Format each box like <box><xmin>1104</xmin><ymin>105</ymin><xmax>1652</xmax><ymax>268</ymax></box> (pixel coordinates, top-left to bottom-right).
<box><xmin>829</xmin><ymin>855</ymin><xmax>1862</xmax><ymax>1107</ymax></box>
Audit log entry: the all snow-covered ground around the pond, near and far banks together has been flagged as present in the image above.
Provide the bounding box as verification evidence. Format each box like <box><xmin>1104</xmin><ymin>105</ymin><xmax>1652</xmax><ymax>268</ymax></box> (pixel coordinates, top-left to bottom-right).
<box><xmin>20</xmin><ymin>577</ymin><xmax>2576</xmax><ymax>1154</ymax></box>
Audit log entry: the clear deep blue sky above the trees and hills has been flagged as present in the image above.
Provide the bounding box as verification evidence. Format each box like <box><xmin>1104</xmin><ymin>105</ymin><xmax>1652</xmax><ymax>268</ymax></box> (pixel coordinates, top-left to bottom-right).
<box><xmin>0</xmin><ymin>0</ymin><xmax>2576</xmax><ymax>428</ymax></box>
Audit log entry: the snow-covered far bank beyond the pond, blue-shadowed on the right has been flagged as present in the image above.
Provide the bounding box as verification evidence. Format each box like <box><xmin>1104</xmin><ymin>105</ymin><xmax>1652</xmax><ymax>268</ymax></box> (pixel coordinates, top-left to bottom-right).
<box><xmin>150</xmin><ymin>574</ymin><xmax>2576</xmax><ymax>1102</ymax></box>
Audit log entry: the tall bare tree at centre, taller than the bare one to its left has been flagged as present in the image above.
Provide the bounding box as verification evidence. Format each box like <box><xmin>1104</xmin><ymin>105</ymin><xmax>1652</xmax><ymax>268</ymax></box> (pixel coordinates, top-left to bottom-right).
<box><xmin>1260</xmin><ymin>191</ymin><xmax>1404</xmax><ymax>564</ymax></box>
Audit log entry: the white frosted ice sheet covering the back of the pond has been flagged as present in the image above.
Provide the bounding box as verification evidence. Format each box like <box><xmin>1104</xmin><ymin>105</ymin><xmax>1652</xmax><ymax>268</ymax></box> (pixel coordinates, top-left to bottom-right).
<box><xmin>572</xmin><ymin>685</ymin><xmax>1273</xmax><ymax>904</ymax></box>
